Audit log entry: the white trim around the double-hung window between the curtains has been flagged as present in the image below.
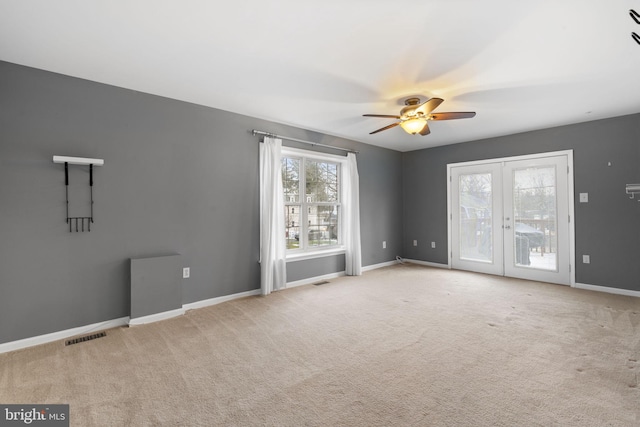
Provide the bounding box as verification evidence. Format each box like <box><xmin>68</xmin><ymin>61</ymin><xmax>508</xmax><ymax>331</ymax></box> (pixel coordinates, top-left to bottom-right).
<box><xmin>281</xmin><ymin>146</ymin><xmax>347</xmax><ymax>261</ymax></box>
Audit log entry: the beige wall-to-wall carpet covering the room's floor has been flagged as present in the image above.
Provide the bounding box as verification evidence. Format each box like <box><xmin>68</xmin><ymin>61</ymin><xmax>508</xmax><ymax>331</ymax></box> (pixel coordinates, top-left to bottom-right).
<box><xmin>0</xmin><ymin>265</ymin><xmax>640</xmax><ymax>427</ymax></box>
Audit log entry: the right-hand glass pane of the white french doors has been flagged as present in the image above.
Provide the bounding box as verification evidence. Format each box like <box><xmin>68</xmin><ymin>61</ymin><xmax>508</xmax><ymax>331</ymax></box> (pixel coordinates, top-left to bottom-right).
<box><xmin>513</xmin><ymin>166</ymin><xmax>558</xmax><ymax>271</ymax></box>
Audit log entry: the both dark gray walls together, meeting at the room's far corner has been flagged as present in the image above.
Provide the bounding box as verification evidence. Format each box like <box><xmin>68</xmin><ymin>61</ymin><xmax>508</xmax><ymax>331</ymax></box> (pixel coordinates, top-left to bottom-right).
<box><xmin>0</xmin><ymin>58</ymin><xmax>640</xmax><ymax>343</ymax></box>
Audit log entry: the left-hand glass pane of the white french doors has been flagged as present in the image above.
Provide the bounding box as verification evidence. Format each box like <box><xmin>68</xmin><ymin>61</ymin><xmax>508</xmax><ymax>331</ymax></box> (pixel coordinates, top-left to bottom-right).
<box><xmin>458</xmin><ymin>173</ymin><xmax>493</xmax><ymax>262</ymax></box>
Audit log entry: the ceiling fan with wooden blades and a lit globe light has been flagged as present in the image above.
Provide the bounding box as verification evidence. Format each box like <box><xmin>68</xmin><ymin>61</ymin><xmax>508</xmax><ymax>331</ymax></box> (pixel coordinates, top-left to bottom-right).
<box><xmin>363</xmin><ymin>98</ymin><xmax>476</xmax><ymax>135</ymax></box>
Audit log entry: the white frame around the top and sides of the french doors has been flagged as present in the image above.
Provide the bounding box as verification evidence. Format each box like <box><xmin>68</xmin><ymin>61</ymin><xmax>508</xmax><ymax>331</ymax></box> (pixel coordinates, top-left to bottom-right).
<box><xmin>447</xmin><ymin>150</ymin><xmax>576</xmax><ymax>287</ymax></box>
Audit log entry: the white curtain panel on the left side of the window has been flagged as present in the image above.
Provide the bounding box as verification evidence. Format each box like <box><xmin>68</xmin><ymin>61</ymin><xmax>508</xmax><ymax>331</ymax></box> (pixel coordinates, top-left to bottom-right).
<box><xmin>260</xmin><ymin>137</ymin><xmax>287</xmax><ymax>295</ymax></box>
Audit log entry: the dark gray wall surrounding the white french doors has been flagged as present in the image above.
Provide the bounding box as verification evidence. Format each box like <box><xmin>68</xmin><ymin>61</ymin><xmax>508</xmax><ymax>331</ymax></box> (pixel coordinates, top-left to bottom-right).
<box><xmin>403</xmin><ymin>114</ymin><xmax>640</xmax><ymax>290</ymax></box>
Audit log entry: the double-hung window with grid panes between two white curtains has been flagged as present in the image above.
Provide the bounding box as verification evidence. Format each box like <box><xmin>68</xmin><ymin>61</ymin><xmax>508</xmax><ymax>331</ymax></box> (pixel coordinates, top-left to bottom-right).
<box><xmin>282</xmin><ymin>150</ymin><xmax>342</xmax><ymax>252</ymax></box>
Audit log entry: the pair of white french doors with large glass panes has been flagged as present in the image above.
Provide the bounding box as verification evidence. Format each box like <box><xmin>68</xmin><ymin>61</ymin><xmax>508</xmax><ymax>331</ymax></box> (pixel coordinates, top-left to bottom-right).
<box><xmin>448</xmin><ymin>154</ymin><xmax>573</xmax><ymax>285</ymax></box>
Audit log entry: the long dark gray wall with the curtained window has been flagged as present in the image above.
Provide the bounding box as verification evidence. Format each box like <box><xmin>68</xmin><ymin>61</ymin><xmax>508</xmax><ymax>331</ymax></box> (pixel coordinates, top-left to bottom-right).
<box><xmin>0</xmin><ymin>62</ymin><xmax>402</xmax><ymax>343</ymax></box>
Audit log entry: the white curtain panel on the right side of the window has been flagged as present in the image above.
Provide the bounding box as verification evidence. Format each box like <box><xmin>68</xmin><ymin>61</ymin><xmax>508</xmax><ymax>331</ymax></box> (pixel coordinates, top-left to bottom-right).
<box><xmin>343</xmin><ymin>153</ymin><xmax>362</xmax><ymax>276</ymax></box>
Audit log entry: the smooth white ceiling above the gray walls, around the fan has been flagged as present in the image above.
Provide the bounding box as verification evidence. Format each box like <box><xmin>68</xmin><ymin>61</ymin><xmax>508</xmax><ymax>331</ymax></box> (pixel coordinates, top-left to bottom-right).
<box><xmin>0</xmin><ymin>0</ymin><xmax>640</xmax><ymax>151</ymax></box>
